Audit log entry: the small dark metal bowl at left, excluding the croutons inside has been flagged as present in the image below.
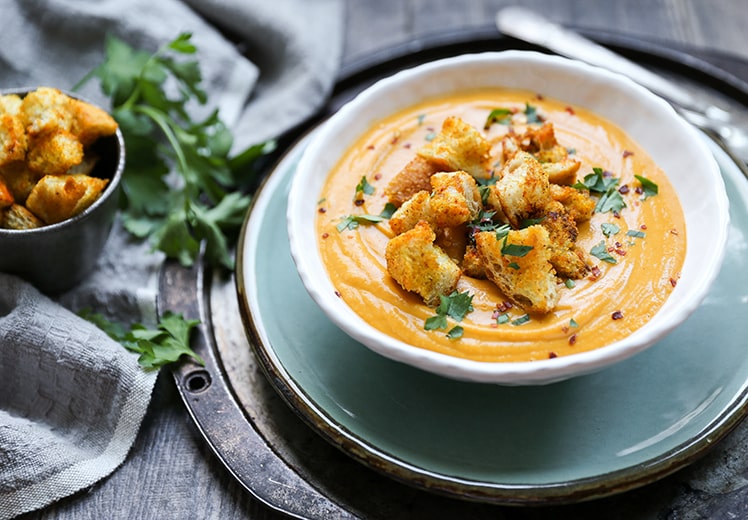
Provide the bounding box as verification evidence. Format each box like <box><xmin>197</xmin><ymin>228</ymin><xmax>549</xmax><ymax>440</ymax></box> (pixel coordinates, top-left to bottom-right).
<box><xmin>0</xmin><ymin>88</ymin><xmax>125</xmax><ymax>295</ymax></box>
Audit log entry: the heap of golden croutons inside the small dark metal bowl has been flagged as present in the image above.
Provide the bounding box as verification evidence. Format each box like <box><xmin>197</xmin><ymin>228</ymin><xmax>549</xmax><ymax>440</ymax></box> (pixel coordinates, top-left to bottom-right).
<box><xmin>0</xmin><ymin>87</ymin><xmax>117</xmax><ymax>229</ymax></box>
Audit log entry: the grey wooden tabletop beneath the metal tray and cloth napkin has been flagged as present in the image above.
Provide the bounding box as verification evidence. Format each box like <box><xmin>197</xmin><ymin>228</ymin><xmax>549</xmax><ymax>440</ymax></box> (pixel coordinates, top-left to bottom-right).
<box><xmin>24</xmin><ymin>0</ymin><xmax>748</xmax><ymax>519</ymax></box>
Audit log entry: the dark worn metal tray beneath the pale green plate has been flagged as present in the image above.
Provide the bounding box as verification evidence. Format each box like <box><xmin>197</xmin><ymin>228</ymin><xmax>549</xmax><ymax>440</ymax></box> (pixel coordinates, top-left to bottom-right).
<box><xmin>160</xmin><ymin>29</ymin><xmax>748</xmax><ymax>518</ymax></box>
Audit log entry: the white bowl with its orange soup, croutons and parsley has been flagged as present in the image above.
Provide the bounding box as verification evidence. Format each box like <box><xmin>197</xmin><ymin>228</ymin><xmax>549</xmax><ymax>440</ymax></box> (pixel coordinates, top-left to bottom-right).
<box><xmin>288</xmin><ymin>51</ymin><xmax>729</xmax><ymax>385</ymax></box>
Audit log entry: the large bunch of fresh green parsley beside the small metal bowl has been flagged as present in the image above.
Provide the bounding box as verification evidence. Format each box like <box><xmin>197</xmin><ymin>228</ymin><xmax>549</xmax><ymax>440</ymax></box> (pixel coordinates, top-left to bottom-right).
<box><xmin>74</xmin><ymin>33</ymin><xmax>273</xmax><ymax>269</ymax></box>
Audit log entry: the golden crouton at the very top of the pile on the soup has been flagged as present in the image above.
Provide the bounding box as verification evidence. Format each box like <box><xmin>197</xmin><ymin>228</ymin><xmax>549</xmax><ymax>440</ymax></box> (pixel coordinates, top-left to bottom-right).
<box><xmin>417</xmin><ymin>116</ymin><xmax>491</xmax><ymax>179</ymax></box>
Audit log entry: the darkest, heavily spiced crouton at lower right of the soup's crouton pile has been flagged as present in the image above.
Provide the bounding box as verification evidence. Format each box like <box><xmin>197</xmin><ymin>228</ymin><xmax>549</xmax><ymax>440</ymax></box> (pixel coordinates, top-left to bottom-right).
<box><xmin>541</xmin><ymin>201</ymin><xmax>590</xmax><ymax>280</ymax></box>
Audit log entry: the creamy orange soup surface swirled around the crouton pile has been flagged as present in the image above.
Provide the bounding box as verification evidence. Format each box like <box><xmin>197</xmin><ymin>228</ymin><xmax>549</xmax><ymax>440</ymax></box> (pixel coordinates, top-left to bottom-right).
<box><xmin>316</xmin><ymin>89</ymin><xmax>686</xmax><ymax>362</ymax></box>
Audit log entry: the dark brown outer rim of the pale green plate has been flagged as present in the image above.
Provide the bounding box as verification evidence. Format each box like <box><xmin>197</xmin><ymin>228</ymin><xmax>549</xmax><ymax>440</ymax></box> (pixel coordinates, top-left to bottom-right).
<box><xmin>235</xmin><ymin>129</ymin><xmax>748</xmax><ymax>505</ymax></box>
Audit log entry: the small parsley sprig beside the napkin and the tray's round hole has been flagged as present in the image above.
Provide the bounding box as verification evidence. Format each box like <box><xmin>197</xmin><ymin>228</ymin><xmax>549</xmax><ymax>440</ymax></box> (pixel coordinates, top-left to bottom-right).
<box><xmin>80</xmin><ymin>309</ymin><xmax>205</xmax><ymax>369</ymax></box>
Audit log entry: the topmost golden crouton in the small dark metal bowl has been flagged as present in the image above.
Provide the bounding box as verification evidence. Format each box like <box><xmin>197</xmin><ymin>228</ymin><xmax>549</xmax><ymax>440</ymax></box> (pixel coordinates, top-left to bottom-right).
<box><xmin>21</xmin><ymin>87</ymin><xmax>73</xmax><ymax>136</ymax></box>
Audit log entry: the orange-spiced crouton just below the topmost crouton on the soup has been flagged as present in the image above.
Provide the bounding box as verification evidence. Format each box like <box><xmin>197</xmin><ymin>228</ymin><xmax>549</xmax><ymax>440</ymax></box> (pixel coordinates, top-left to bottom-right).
<box><xmin>430</xmin><ymin>171</ymin><xmax>483</xmax><ymax>227</ymax></box>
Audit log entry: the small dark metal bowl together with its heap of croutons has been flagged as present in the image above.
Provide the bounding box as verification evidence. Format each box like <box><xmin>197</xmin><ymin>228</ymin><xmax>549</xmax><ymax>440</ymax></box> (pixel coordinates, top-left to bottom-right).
<box><xmin>0</xmin><ymin>87</ymin><xmax>125</xmax><ymax>294</ymax></box>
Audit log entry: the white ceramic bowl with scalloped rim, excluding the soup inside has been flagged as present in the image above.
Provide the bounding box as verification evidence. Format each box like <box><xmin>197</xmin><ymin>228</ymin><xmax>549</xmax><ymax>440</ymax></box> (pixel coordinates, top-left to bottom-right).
<box><xmin>288</xmin><ymin>51</ymin><xmax>729</xmax><ymax>385</ymax></box>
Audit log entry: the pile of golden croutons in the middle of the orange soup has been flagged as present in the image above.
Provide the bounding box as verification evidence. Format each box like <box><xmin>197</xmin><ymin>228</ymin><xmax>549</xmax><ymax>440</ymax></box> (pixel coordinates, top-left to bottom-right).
<box><xmin>385</xmin><ymin>117</ymin><xmax>595</xmax><ymax>314</ymax></box>
